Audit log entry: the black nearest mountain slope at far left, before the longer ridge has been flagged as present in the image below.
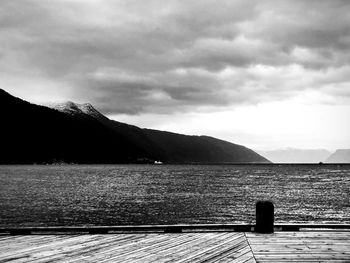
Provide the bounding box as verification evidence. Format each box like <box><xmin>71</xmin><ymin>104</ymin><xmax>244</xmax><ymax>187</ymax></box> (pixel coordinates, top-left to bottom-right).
<box><xmin>0</xmin><ymin>90</ymin><xmax>147</xmax><ymax>163</ymax></box>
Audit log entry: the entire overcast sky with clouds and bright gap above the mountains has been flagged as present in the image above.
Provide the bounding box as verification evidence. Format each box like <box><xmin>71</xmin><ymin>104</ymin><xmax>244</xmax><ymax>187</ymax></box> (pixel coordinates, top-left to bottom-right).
<box><xmin>0</xmin><ymin>0</ymin><xmax>350</xmax><ymax>150</ymax></box>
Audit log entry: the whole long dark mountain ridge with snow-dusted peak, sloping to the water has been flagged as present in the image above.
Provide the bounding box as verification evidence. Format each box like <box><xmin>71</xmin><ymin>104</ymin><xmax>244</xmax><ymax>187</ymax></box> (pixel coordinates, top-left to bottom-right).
<box><xmin>0</xmin><ymin>89</ymin><xmax>269</xmax><ymax>164</ymax></box>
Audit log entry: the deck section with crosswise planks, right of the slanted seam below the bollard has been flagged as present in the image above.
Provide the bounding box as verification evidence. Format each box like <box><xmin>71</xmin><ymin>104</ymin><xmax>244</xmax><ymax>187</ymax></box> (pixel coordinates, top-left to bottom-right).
<box><xmin>246</xmin><ymin>232</ymin><xmax>350</xmax><ymax>262</ymax></box>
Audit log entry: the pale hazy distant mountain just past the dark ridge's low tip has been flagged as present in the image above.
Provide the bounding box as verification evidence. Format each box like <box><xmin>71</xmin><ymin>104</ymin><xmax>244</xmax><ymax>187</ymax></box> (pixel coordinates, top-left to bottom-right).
<box><xmin>258</xmin><ymin>148</ymin><xmax>331</xmax><ymax>163</ymax></box>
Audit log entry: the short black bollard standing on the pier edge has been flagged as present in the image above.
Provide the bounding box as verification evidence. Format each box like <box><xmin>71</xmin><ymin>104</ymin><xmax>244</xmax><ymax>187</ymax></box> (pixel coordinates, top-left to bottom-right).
<box><xmin>255</xmin><ymin>201</ymin><xmax>274</xmax><ymax>234</ymax></box>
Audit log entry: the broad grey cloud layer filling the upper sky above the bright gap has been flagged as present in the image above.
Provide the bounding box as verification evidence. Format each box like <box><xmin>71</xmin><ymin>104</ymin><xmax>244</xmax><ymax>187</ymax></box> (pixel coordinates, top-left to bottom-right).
<box><xmin>0</xmin><ymin>0</ymin><xmax>350</xmax><ymax>114</ymax></box>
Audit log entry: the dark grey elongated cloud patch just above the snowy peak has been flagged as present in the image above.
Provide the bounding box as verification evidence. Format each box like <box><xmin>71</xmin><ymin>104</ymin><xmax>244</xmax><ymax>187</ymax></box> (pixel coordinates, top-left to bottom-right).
<box><xmin>79</xmin><ymin>77</ymin><xmax>232</xmax><ymax>114</ymax></box>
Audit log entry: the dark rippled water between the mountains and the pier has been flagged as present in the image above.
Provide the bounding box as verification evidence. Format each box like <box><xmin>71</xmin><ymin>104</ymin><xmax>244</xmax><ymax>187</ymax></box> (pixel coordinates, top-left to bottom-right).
<box><xmin>0</xmin><ymin>165</ymin><xmax>350</xmax><ymax>226</ymax></box>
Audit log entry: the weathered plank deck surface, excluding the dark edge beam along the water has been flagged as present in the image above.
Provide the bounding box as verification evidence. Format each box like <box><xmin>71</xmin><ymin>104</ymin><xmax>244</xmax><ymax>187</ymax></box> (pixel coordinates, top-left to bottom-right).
<box><xmin>0</xmin><ymin>231</ymin><xmax>350</xmax><ymax>263</ymax></box>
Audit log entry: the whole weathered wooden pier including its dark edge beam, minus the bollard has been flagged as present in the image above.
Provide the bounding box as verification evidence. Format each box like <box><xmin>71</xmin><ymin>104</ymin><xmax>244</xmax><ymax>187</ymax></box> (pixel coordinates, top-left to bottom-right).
<box><xmin>0</xmin><ymin>225</ymin><xmax>350</xmax><ymax>262</ymax></box>
